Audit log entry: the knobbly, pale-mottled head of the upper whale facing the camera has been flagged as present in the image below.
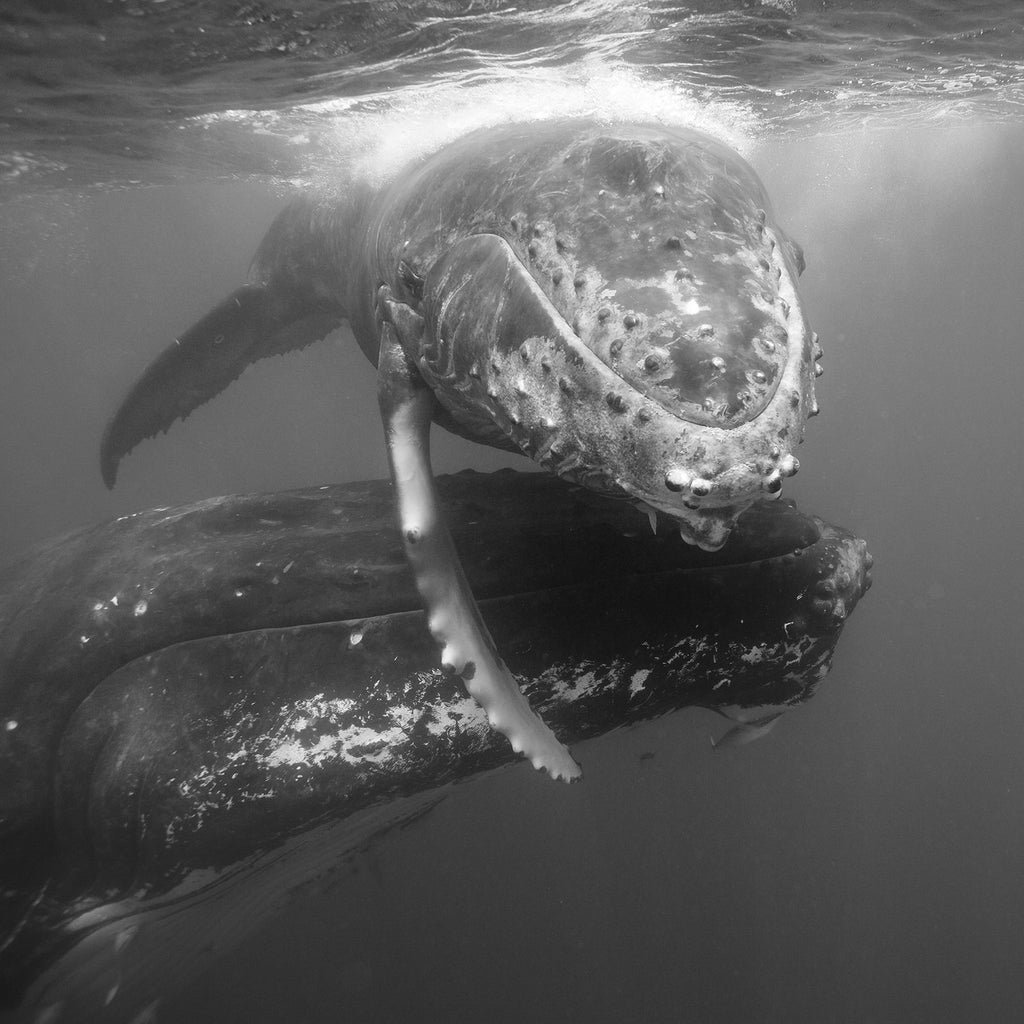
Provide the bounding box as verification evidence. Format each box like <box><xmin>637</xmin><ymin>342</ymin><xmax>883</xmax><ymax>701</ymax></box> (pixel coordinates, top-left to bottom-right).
<box><xmin>411</xmin><ymin>126</ymin><xmax>820</xmax><ymax>550</ymax></box>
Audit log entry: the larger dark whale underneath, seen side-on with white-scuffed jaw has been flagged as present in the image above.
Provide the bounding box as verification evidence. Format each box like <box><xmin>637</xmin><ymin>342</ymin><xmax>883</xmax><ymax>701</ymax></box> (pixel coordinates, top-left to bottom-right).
<box><xmin>0</xmin><ymin>470</ymin><xmax>872</xmax><ymax>1021</ymax></box>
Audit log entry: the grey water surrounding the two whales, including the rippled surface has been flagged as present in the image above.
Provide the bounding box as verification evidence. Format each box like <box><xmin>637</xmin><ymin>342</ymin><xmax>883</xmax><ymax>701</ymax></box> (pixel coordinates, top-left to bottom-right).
<box><xmin>0</xmin><ymin>0</ymin><xmax>1024</xmax><ymax>1024</ymax></box>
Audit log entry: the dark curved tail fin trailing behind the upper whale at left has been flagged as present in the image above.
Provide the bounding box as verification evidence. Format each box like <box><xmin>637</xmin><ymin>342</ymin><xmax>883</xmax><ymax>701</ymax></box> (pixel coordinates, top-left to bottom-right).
<box><xmin>99</xmin><ymin>285</ymin><xmax>343</xmax><ymax>487</ymax></box>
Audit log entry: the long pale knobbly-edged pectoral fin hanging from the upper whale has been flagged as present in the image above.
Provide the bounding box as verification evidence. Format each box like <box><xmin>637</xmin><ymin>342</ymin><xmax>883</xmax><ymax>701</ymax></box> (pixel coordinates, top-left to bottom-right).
<box><xmin>377</xmin><ymin>290</ymin><xmax>581</xmax><ymax>781</ymax></box>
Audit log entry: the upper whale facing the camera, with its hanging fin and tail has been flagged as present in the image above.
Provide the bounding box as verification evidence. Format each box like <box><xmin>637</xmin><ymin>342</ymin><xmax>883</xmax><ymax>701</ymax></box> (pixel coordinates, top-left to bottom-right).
<box><xmin>101</xmin><ymin>120</ymin><xmax>820</xmax><ymax>780</ymax></box>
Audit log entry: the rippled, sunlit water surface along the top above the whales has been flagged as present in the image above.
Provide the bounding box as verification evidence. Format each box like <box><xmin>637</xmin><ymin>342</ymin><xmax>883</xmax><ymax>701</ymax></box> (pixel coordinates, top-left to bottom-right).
<box><xmin>6</xmin><ymin>0</ymin><xmax>1024</xmax><ymax>188</ymax></box>
